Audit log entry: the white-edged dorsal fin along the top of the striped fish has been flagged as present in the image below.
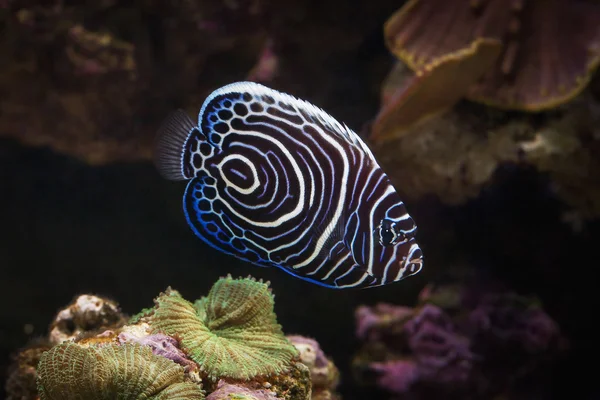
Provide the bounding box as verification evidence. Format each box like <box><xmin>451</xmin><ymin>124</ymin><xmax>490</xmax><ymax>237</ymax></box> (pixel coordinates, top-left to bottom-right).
<box><xmin>198</xmin><ymin>82</ymin><xmax>370</xmax><ymax>153</ymax></box>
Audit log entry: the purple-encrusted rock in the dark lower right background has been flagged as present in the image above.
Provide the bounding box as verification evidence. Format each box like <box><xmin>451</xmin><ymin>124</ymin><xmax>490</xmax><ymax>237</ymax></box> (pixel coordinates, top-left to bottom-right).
<box><xmin>353</xmin><ymin>285</ymin><xmax>565</xmax><ymax>399</ymax></box>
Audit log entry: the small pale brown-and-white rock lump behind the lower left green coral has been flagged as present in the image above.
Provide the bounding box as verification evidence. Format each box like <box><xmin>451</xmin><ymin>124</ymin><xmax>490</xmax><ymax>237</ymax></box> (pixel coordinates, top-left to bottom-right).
<box><xmin>49</xmin><ymin>294</ymin><xmax>125</xmax><ymax>344</ymax></box>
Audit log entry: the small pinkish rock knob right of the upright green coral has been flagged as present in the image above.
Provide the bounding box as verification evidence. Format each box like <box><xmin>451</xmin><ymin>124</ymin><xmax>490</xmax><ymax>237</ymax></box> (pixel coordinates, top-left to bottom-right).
<box><xmin>287</xmin><ymin>335</ymin><xmax>340</xmax><ymax>399</ymax></box>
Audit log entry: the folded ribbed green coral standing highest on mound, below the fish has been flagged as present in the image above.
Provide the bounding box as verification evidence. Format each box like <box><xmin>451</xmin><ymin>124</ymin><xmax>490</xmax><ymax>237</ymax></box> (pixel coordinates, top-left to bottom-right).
<box><xmin>150</xmin><ymin>276</ymin><xmax>298</xmax><ymax>380</ymax></box>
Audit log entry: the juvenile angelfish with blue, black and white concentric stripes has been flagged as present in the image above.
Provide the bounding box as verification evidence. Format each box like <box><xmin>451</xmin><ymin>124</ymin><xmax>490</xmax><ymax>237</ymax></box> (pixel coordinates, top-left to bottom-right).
<box><xmin>155</xmin><ymin>82</ymin><xmax>423</xmax><ymax>289</ymax></box>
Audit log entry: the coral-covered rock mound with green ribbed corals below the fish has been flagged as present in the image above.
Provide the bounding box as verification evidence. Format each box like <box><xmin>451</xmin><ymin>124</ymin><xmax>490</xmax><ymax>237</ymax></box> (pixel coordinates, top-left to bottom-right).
<box><xmin>6</xmin><ymin>276</ymin><xmax>324</xmax><ymax>400</ymax></box>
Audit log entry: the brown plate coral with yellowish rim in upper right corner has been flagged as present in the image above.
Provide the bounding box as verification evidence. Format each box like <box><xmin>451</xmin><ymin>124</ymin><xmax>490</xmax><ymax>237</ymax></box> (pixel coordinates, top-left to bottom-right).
<box><xmin>374</xmin><ymin>0</ymin><xmax>600</xmax><ymax>138</ymax></box>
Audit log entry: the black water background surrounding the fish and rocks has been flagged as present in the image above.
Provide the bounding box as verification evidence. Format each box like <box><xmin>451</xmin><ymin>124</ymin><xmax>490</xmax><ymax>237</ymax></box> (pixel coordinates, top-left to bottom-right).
<box><xmin>0</xmin><ymin>1</ymin><xmax>600</xmax><ymax>399</ymax></box>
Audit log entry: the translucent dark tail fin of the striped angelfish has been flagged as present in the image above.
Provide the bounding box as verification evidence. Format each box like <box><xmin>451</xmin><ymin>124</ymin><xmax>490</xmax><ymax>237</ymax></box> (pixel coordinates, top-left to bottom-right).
<box><xmin>153</xmin><ymin>110</ymin><xmax>197</xmax><ymax>181</ymax></box>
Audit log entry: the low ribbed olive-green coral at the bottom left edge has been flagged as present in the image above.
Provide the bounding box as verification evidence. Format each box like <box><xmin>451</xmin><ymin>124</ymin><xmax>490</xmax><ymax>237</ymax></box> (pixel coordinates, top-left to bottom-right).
<box><xmin>38</xmin><ymin>342</ymin><xmax>204</xmax><ymax>400</ymax></box>
